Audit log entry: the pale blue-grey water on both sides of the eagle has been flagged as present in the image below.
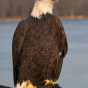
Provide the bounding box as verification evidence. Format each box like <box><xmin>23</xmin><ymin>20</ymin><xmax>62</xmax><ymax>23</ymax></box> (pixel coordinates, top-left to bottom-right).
<box><xmin>0</xmin><ymin>20</ymin><xmax>88</xmax><ymax>88</ymax></box>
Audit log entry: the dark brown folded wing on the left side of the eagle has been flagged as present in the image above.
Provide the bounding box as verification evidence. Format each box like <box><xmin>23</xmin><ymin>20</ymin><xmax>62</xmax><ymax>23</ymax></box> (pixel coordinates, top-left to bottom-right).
<box><xmin>12</xmin><ymin>21</ymin><xmax>26</xmax><ymax>85</ymax></box>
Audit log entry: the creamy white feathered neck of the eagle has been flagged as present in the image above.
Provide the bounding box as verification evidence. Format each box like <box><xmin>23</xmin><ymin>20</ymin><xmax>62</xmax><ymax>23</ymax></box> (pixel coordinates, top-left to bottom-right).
<box><xmin>31</xmin><ymin>0</ymin><xmax>54</xmax><ymax>18</ymax></box>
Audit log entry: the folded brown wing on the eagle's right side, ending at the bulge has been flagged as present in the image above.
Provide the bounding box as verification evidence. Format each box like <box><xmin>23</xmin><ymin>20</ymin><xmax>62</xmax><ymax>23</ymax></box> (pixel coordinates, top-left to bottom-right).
<box><xmin>56</xmin><ymin>19</ymin><xmax>68</xmax><ymax>59</ymax></box>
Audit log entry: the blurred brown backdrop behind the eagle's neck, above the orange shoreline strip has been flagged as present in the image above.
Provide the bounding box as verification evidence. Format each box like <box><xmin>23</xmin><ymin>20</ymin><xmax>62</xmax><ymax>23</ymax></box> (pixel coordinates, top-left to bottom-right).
<box><xmin>0</xmin><ymin>0</ymin><xmax>88</xmax><ymax>17</ymax></box>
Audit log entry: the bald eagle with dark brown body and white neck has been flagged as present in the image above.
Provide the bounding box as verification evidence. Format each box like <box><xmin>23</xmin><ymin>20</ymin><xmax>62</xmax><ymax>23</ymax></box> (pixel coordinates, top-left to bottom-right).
<box><xmin>12</xmin><ymin>0</ymin><xmax>68</xmax><ymax>86</ymax></box>
